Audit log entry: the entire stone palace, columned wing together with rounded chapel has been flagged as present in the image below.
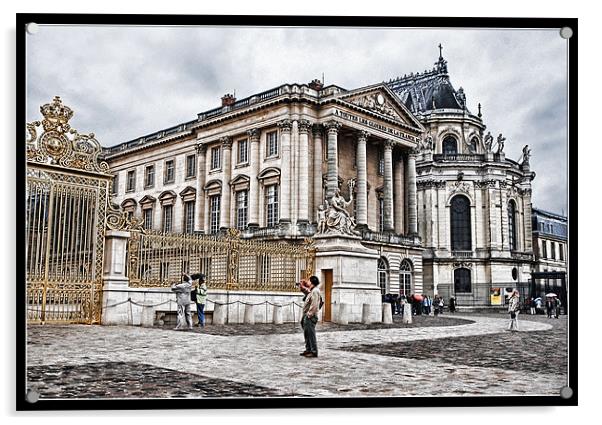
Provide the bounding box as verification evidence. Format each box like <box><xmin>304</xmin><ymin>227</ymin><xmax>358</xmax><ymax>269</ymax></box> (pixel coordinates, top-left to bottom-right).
<box><xmin>103</xmin><ymin>49</ymin><xmax>535</xmax><ymax>306</ymax></box>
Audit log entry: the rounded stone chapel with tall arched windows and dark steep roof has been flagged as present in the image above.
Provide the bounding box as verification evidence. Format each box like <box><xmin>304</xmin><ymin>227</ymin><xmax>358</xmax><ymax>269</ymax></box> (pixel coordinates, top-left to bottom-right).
<box><xmin>389</xmin><ymin>51</ymin><xmax>535</xmax><ymax>307</ymax></box>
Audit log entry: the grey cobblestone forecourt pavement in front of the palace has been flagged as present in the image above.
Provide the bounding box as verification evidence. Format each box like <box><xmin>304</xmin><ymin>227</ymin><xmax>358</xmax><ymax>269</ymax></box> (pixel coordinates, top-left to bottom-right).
<box><xmin>27</xmin><ymin>314</ymin><xmax>566</xmax><ymax>398</ymax></box>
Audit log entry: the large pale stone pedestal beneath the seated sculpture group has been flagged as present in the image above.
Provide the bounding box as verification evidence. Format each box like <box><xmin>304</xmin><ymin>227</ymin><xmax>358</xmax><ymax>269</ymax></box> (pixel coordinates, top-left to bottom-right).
<box><xmin>315</xmin><ymin>235</ymin><xmax>382</xmax><ymax>323</ymax></box>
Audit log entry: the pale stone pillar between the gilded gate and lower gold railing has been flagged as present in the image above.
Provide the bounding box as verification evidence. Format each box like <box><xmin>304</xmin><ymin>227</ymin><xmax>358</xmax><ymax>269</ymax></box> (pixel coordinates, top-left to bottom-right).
<box><xmin>101</xmin><ymin>230</ymin><xmax>132</xmax><ymax>325</ymax></box>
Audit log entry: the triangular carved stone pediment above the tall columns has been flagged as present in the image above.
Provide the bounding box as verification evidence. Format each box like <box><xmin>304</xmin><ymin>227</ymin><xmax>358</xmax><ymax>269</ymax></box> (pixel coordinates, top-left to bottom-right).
<box><xmin>339</xmin><ymin>84</ymin><xmax>422</xmax><ymax>130</ymax></box>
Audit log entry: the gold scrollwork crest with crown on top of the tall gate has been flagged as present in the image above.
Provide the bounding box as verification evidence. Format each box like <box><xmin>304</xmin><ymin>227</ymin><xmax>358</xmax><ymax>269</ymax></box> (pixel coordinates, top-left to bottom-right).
<box><xmin>26</xmin><ymin>96</ymin><xmax>109</xmax><ymax>174</ymax></box>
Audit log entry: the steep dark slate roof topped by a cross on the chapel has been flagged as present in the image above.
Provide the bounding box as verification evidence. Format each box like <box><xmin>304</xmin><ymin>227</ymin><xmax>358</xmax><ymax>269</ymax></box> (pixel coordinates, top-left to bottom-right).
<box><xmin>385</xmin><ymin>55</ymin><xmax>470</xmax><ymax>114</ymax></box>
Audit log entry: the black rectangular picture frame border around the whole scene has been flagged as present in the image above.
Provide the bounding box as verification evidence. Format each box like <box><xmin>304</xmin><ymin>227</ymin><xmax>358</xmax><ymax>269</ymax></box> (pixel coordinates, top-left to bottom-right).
<box><xmin>15</xmin><ymin>13</ymin><xmax>579</xmax><ymax>411</ymax></box>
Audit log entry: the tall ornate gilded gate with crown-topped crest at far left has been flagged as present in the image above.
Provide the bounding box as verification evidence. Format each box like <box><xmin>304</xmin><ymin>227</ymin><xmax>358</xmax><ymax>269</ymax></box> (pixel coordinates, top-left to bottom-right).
<box><xmin>25</xmin><ymin>96</ymin><xmax>118</xmax><ymax>323</ymax></box>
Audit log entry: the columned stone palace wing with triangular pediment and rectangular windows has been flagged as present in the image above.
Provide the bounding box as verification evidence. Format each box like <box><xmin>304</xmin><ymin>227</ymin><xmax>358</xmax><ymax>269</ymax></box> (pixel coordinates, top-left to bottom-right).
<box><xmin>104</xmin><ymin>79</ymin><xmax>424</xmax><ymax>321</ymax></box>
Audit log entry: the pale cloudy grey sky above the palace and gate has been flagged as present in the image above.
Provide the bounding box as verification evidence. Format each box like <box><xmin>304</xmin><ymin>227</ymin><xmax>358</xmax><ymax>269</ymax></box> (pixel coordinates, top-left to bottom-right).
<box><xmin>27</xmin><ymin>26</ymin><xmax>567</xmax><ymax>212</ymax></box>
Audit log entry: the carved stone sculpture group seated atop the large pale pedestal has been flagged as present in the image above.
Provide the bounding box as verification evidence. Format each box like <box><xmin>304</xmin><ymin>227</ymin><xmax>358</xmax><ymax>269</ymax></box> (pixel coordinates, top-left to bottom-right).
<box><xmin>317</xmin><ymin>180</ymin><xmax>359</xmax><ymax>236</ymax></box>
